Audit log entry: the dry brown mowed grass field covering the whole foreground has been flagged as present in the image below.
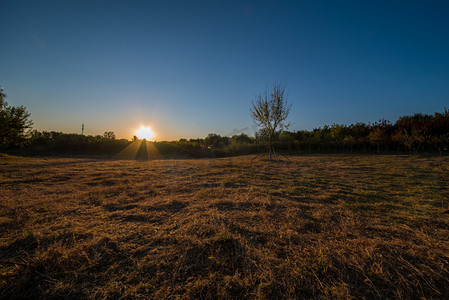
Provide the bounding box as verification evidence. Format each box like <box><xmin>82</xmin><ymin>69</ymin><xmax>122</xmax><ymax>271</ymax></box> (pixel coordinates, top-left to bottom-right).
<box><xmin>0</xmin><ymin>155</ymin><xmax>449</xmax><ymax>299</ymax></box>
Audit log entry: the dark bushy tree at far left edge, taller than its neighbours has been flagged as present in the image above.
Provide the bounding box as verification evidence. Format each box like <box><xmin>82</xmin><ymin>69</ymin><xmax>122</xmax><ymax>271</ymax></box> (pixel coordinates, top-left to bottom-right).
<box><xmin>0</xmin><ymin>87</ymin><xmax>33</xmax><ymax>147</ymax></box>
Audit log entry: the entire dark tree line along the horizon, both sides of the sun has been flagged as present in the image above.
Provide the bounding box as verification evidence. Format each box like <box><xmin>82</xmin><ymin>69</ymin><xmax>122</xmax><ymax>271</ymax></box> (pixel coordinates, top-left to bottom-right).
<box><xmin>0</xmin><ymin>86</ymin><xmax>449</xmax><ymax>157</ymax></box>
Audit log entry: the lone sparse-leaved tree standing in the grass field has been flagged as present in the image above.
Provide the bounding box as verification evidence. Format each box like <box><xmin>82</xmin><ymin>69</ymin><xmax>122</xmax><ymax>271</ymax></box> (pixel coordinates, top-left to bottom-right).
<box><xmin>250</xmin><ymin>83</ymin><xmax>291</xmax><ymax>160</ymax></box>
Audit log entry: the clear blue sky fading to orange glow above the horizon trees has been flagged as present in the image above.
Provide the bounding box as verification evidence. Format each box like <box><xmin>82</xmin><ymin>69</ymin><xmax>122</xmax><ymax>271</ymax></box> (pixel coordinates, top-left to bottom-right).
<box><xmin>0</xmin><ymin>0</ymin><xmax>449</xmax><ymax>140</ymax></box>
